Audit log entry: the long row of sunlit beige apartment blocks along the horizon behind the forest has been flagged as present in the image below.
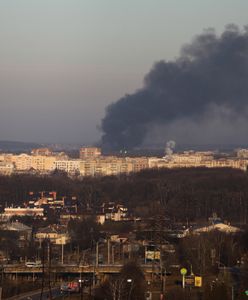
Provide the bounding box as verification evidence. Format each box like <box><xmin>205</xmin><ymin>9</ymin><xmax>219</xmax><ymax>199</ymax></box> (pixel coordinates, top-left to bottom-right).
<box><xmin>0</xmin><ymin>147</ymin><xmax>248</xmax><ymax>176</ymax></box>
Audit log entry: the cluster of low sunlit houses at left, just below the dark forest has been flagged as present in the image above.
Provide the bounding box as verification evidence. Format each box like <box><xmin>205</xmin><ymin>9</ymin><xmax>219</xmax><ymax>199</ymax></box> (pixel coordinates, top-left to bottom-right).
<box><xmin>0</xmin><ymin>191</ymin><xmax>132</xmax><ymax>225</ymax></box>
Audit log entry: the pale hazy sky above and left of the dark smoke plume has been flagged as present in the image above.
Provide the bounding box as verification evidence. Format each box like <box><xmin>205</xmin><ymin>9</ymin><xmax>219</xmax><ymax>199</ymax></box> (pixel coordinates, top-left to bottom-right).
<box><xmin>0</xmin><ymin>0</ymin><xmax>248</xmax><ymax>143</ymax></box>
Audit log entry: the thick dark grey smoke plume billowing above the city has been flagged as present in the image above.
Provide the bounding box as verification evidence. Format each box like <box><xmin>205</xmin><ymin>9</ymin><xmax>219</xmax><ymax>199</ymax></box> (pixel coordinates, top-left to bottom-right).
<box><xmin>101</xmin><ymin>25</ymin><xmax>248</xmax><ymax>150</ymax></box>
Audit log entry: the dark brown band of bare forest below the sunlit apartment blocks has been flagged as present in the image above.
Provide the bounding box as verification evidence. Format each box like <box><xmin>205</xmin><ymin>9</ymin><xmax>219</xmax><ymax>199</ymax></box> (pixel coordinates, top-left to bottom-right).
<box><xmin>0</xmin><ymin>168</ymin><xmax>248</xmax><ymax>224</ymax></box>
